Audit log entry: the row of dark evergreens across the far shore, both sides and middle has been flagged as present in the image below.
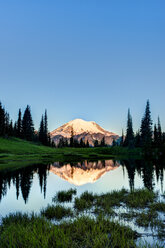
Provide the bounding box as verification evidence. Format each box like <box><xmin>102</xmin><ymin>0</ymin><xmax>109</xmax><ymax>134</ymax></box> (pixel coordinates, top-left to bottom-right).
<box><xmin>0</xmin><ymin>100</ymin><xmax>165</xmax><ymax>151</ymax></box>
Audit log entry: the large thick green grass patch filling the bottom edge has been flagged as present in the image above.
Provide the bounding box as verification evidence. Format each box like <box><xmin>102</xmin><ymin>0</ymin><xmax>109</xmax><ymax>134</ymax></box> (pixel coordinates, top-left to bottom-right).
<box><xmin>0</xmin><ymin>213</ymin><xmax>138</xmax><ymax>248</ymax></box>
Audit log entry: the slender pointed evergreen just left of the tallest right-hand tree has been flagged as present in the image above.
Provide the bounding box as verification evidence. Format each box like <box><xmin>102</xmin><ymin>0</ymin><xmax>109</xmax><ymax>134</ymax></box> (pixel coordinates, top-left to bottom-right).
<box><xmin>124</xmin><ymin>109</ymin><xmax>134</xmax><ymax>148</ymax></box>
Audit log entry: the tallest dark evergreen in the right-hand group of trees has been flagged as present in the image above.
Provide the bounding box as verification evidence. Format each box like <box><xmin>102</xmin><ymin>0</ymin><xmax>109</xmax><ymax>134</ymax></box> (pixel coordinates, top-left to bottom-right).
<box><xmin>140</xmin><ymin>100</ymin><xmax>152</xmax><ymax>148</ymax></box>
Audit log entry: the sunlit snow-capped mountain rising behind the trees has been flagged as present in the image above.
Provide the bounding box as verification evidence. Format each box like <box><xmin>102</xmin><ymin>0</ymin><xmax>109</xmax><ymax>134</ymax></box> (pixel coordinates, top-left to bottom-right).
<box><xmin>50</xmin><ymin>119</ymin><xmax>119</xmax><ymax>146</ymax></box>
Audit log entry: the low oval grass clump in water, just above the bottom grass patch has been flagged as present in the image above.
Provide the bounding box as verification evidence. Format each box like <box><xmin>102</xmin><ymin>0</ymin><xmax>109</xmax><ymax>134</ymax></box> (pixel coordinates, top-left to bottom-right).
<box><xmin>41</xmin><ymin>205</ymin><xmax>73</xmax><ymax>220</ymax></box>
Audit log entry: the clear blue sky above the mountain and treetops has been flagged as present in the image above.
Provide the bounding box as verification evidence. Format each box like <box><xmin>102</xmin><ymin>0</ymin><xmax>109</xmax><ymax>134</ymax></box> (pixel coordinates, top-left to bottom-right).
<box><xmin>0</xmin><ymin>0</ymin><xmax>165</xmax><ymax>134</ymax></box>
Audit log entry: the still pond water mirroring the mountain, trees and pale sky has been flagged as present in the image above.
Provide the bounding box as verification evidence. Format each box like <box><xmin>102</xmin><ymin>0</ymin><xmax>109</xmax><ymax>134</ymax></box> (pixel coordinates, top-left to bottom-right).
<box><xmin>0</xmin><ymin>159</ymin><xmax>165</xmax><ymax>217</ymax></box>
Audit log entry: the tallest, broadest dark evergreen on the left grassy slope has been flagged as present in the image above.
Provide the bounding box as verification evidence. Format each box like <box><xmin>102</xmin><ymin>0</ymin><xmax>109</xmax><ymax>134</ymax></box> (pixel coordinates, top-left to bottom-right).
<box><xmin>22</xmin><ymin>105</ymin><xmax>34</xmax><ymax>140</ymax></box>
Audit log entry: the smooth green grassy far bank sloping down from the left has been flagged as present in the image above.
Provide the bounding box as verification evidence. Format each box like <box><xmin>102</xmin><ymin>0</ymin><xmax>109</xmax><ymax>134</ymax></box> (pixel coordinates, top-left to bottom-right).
<box><xmin>0</xmin><ymin>138</ymin><xmax>140</xmax><ymax>170</ymax></box>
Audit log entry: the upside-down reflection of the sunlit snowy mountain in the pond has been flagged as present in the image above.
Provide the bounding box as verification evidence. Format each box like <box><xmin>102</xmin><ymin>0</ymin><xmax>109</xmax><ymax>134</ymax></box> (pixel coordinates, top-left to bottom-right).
<box><xmin>50</xmin><ymin>160</ymin><xmax>120</xmax><ymax>186</ymax></box>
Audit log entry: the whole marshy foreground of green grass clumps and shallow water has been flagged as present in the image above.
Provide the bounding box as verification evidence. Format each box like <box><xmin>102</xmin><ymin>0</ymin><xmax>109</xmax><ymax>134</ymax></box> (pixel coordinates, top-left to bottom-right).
<box><xmin>0</xmin><ymin>189</ymin><xmax>165</xmax><ymax>248</ymax></box>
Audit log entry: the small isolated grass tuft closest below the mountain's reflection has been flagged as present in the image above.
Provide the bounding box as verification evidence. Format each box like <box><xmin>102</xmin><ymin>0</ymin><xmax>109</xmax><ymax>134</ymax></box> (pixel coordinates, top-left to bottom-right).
<box><xmin>52</xmin><ymin>189</ymin><xmax>77</xmax><ymax>202</ymax></box>
